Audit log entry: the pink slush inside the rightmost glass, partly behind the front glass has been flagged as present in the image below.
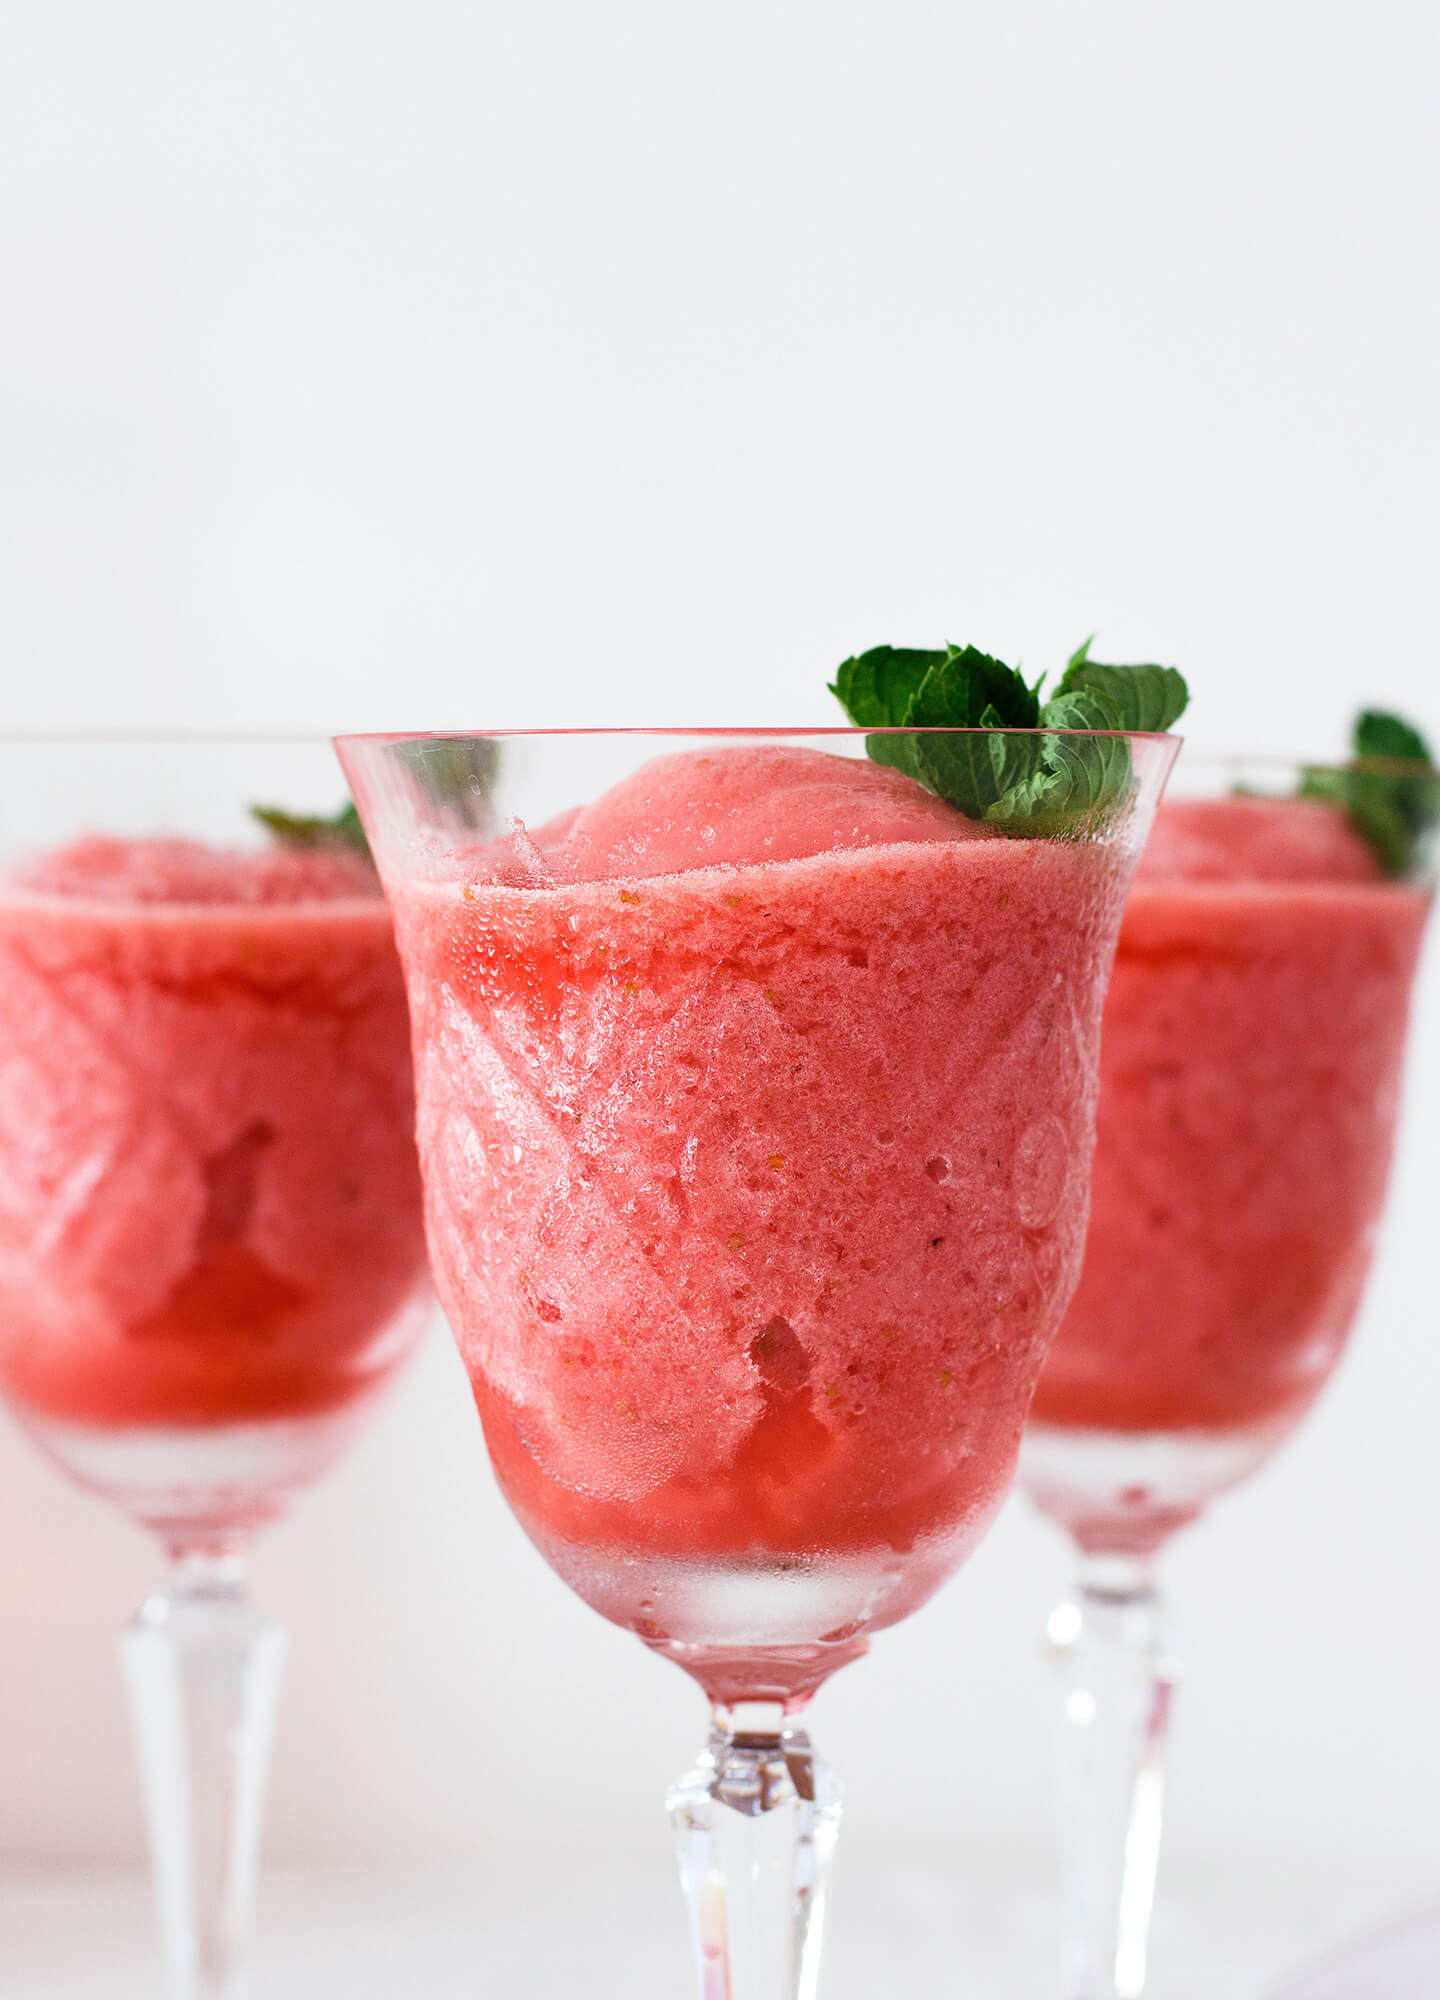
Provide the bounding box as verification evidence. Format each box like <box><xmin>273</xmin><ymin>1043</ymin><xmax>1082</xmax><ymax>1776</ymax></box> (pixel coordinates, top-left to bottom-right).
<box><xmin>1034</xmin><ymin>798</ymin><xmax>1428</xmax><ymax>1432</ymax></box>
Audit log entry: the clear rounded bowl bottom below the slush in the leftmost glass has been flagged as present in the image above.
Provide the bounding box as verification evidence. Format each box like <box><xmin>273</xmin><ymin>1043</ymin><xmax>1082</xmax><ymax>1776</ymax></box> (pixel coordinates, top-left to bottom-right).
<box><xmin>22</xmin><ymin>1392</ymin><xmax>386</xmax><ymax>1548</ymax></box>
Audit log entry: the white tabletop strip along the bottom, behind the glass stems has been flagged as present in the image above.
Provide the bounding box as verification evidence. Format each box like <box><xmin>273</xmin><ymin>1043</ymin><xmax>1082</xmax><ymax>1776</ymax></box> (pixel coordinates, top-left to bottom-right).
<box><xmin>0</xmin><ymin>1852</ymin><xmax>1416</xmax><ymax>2000</ymax></box>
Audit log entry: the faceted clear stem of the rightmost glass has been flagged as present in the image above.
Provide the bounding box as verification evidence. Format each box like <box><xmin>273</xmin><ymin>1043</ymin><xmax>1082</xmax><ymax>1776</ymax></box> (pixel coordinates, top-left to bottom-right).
<box><xmin>1048</xmin><ymin>1556</ymin><xmax>1180</xmax><ymax>2000</ymax></box>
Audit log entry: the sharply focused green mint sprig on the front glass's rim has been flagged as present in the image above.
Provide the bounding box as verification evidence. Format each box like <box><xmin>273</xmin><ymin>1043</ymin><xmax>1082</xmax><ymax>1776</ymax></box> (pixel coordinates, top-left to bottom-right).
<box><xmin>830</xmin><ymin>640</ymin><xmax>1188</xmax><ymax>836</ymax></box>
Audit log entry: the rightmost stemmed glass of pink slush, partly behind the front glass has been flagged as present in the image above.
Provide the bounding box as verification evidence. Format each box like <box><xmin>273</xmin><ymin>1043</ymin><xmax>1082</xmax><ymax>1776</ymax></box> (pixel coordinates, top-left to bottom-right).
<box><xmin>1020</xmin><ymin>758</ymin><xmax>1434</xmax><ymax>2000</ymax></box>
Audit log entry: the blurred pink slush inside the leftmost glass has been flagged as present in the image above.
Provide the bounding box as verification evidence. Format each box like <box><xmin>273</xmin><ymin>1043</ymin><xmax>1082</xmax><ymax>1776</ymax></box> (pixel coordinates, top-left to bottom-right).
<box><xmin>0</xmin><ymin>838</ymin><xmax>424</xmax><ymax>1428</ymax></box>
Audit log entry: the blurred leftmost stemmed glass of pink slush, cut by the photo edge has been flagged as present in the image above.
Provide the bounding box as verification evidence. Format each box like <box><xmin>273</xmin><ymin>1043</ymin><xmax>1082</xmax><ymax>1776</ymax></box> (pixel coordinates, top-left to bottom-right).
<box><xmin>0</xmin><ymin>736</ymin><xmax>426</xmax><ymax>2000</ymax></box>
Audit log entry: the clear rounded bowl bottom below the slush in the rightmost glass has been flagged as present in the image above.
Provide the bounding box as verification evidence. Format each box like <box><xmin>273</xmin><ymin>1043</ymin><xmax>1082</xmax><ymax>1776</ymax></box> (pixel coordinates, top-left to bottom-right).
<box><xmin>1020</xmin><ymin>1418</ymin><xmax>1292</xmax><ymax>1556</ymax></box>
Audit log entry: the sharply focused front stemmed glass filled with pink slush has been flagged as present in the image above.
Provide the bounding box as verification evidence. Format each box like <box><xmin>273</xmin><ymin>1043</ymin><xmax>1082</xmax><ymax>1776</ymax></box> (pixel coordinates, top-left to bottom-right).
<box><xmin>340</xmin><ymin>730</ymin><xmax>1174</xmax><ymax>2000</ymax></box>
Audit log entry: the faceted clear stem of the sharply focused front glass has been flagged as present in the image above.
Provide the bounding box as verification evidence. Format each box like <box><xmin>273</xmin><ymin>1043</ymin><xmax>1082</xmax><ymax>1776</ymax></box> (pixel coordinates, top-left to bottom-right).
<box><xmin>668</xmin><ymin>1702</ymin><xmax>840</xmax><ymax>2000</ymax></box>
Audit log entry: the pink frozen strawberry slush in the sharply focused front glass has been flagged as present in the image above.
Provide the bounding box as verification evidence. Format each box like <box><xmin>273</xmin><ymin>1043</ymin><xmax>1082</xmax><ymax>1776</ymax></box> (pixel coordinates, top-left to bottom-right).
<box><xmin>388</xmin><ymin>746</ymin><xmax>1128</xmax><ymax>1580</ymax></box>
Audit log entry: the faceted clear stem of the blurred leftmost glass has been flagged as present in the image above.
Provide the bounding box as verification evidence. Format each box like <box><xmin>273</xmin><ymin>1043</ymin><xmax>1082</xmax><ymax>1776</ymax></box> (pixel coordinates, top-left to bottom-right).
<box><xmin>120</xmin><ymin>1550</ymin><xmax>286</xmax><ymax>2000</ymax></box>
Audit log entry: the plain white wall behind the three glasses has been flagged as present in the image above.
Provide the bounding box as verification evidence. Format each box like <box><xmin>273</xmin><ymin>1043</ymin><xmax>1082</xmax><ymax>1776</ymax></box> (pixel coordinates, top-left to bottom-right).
<box><xmin>0</xmin><ymin>0</ymin><xmax>1440</xmax><ymax>1992</ymax></box>
